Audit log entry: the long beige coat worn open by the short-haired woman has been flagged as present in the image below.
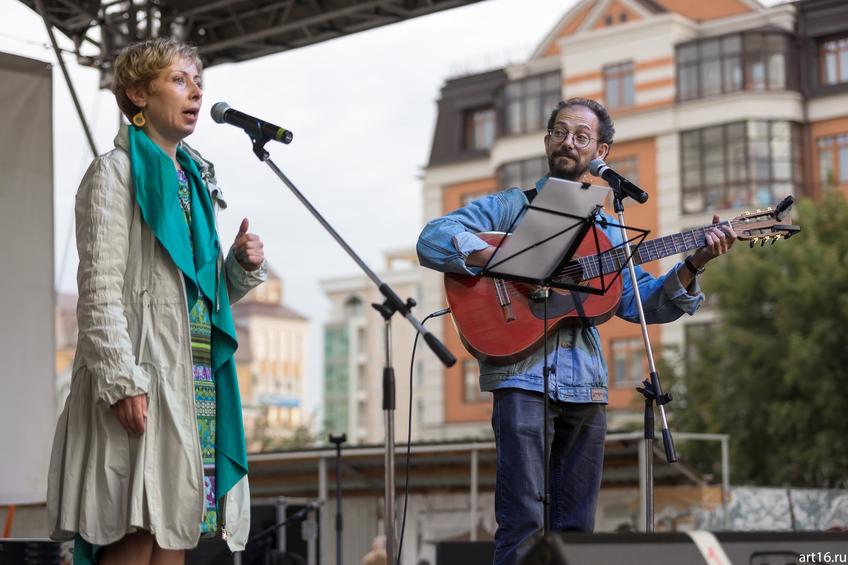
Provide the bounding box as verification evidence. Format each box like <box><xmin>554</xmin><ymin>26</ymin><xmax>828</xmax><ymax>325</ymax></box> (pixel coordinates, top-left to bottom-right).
<box><xmin>47</xmin><ymin>126</ymin><xmax>267</xmax><ymax>551</ymax></box>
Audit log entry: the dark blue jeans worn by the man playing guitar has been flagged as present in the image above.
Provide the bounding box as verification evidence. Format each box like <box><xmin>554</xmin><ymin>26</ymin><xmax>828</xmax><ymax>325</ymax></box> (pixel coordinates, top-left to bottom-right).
<box><xmin>492</xmin><ymin>388</ymin><xmax>607</xmax><ymax>565</ymax></box>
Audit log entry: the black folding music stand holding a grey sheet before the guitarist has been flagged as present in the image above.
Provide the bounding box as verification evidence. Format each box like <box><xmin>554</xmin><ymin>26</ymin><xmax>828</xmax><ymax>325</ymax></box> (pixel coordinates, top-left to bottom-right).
<box><xmin>480</xmin><ymin>177</ymin><xmax>649</xmax><ymax>534</ymax></box>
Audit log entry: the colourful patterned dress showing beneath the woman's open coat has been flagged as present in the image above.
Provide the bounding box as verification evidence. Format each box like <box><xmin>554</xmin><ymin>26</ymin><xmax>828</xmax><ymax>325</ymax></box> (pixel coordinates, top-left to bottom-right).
<box><xmin>177</xmin><ymin>167</ymin><xmax>218</xmax><ymax>535</ymax></box>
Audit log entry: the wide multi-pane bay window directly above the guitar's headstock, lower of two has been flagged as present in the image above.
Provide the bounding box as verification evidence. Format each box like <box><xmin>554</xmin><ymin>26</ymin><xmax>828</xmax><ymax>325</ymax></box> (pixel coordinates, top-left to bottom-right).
<box><xmin>680</xmin><ymin>121</ymin><xmax>802</xmax><ymax>213</ymax></box>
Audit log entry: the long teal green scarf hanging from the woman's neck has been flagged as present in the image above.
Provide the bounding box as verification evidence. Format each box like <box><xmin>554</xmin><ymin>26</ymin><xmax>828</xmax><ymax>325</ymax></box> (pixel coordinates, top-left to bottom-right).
<box><xmin>129</xmin><ymin>126</ymin><xmax>247</xmax><ymax>500</ymax></box>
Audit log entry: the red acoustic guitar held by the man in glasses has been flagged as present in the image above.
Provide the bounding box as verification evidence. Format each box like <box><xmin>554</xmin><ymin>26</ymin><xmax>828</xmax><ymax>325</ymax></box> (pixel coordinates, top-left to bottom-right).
<box><xmin>445</xmin><ymin>196</ymin><xmax>801</xmax><ymax>365</ymax></box>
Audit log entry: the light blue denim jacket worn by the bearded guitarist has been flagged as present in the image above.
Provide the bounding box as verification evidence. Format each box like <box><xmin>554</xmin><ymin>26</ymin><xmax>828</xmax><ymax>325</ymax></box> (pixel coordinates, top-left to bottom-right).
<box><xmin>417</xmin><ymin>177</ymin><xmax>704</xmax><ymax>403</ymax></box>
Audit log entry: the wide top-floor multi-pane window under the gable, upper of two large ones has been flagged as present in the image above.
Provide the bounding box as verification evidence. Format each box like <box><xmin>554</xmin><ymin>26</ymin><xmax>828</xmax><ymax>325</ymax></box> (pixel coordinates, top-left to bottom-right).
<box><xmin>675</xmin><ymin>33</ymin><xmax>796</xmax><ymax>100</ymax></box>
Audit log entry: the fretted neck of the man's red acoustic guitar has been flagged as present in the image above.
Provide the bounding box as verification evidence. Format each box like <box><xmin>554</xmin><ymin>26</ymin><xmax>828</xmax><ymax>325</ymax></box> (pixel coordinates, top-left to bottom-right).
<box><xmin>575</xmin><ymin>221</ymin><xmax>731</xmax><ymax>279</ymax></box>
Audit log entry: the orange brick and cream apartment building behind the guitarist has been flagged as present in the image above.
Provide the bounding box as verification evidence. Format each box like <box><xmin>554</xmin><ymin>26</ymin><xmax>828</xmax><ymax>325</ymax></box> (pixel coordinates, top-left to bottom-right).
<box><xmin>420</xmin><ymin>0</ymin><xmax>848</xmax><ymax>439</ymax></box>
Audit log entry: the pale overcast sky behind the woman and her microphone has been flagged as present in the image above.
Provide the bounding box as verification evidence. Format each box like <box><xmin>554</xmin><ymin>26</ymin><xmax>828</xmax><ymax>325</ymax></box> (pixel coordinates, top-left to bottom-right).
<box><xmin>0</xmin><ymin>0</ymin><xmax>574</xmax><ymax>418</ymax></box>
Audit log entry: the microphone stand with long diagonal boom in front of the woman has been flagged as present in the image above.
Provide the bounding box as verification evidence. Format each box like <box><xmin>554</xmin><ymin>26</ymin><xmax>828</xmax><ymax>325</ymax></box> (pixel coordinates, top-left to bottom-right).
<box><xmin>237</xmin><ymin>122</ymin><xmax>456</xmax><ymax>563</ymax></box>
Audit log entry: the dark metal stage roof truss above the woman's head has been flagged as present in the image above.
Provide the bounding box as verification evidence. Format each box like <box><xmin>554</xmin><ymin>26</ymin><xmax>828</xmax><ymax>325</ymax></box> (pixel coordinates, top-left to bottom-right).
<box><xmin>21</xmin><ymin>0</ymin><xmax>479</xmax><ymax>87</ymax></box>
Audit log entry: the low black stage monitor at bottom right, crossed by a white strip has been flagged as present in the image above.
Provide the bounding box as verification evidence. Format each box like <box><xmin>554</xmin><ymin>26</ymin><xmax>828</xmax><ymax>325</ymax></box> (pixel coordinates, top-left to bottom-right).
<box><xmin>522</xmin><ymin>532</ymin><xmax>848</xmax><ymax>565</ymax></box>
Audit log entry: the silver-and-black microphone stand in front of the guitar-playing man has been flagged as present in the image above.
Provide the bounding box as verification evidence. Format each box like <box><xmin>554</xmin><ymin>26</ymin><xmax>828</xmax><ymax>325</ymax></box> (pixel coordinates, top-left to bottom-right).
<box><xmin>608</xmin><ymin>179</ymin><xmax>677</xmax><ymax>533</ymax></box>
